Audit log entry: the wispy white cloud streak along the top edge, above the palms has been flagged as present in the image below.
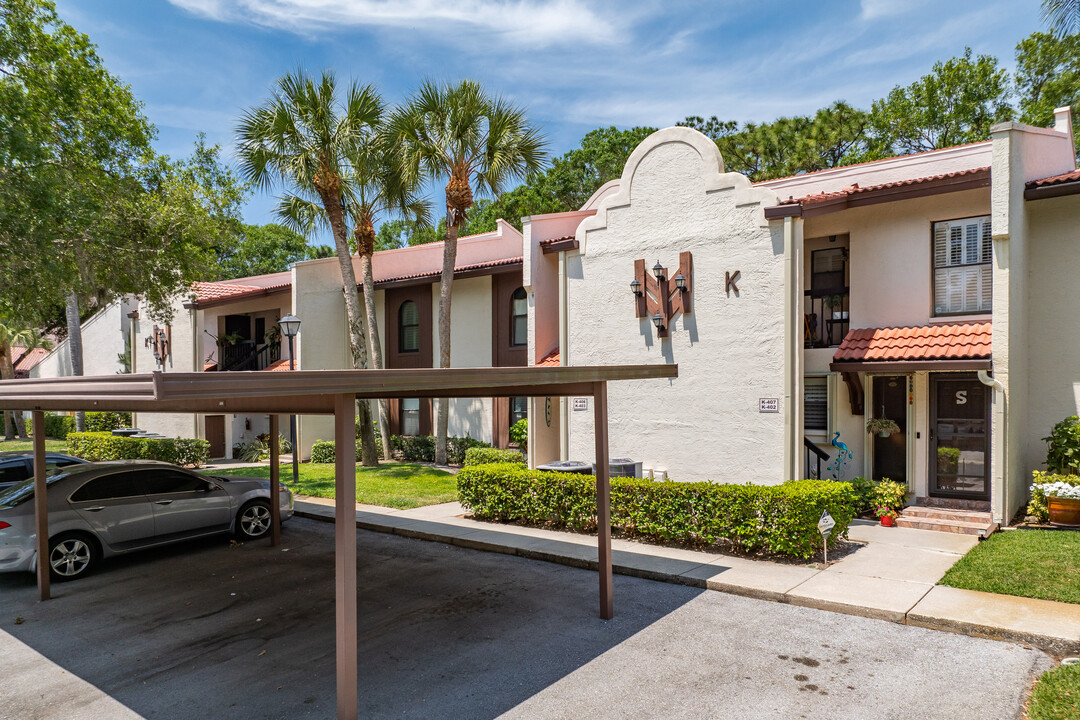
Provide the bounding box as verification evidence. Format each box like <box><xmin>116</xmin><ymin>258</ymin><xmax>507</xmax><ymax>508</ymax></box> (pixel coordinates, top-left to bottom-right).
<box><xmin>170</xmin><ymin>0</ymin><xmax>621</xmax><ymax>46</ymax></box>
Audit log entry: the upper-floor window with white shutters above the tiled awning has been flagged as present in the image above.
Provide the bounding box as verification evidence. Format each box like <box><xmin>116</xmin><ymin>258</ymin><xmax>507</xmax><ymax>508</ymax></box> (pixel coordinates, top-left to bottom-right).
<box><xmin>933</xmin><ymin>215</ymin><xmax>994</xmax><ymax>315</ymax></box>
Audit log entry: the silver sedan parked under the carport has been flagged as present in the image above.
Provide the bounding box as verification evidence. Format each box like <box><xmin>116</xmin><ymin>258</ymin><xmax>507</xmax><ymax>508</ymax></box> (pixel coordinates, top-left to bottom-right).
<box><xmin>0</xmin><ymin>460</ymin><xmax>293</xmax><ymax>580</ymax></box>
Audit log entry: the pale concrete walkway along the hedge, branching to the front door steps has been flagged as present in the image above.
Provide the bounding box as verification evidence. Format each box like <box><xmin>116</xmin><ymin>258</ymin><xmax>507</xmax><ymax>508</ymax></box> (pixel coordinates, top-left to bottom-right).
<box><xmin>296</xmin><ymin>498</ymin><xmax>1080</xmax><ymax>655</ymax></box>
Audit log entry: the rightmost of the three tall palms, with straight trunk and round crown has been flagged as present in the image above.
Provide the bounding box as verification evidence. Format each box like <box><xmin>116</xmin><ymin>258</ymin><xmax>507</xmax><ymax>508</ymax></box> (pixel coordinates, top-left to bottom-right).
<box><xmin>391</xmin><ymin>80</ymin><xmax>546</xmax><ymax>463</ymax></box>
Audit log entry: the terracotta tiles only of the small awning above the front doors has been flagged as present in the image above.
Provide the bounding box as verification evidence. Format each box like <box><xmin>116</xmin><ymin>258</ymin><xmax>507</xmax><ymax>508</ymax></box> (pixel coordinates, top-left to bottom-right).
<box><xmin>833</xmin><ymin>323</ymin><xmax>990</xmax><ymax>363</ymax></box>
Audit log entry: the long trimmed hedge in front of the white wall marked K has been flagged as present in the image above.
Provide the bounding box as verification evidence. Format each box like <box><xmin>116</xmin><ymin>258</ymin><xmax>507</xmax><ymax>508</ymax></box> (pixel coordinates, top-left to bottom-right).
<box><xmin>458</xmin><ymin>463</ymin><xmax>858</xmax><ymax>558</ymax></box>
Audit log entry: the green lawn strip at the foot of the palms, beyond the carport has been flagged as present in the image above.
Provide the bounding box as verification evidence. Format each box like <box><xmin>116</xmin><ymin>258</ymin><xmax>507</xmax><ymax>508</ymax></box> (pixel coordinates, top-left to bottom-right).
<box><xmin>214</xmin><ymin>462</ymin><xmax>458</xmax><ymax>510</ymax></box>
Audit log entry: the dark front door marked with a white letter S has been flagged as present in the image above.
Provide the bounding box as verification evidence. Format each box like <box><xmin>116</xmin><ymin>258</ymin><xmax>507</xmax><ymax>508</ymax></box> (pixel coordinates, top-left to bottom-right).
<box><xmin>930</xmin><ymin>375</ymin><xmax>990</xmax><ymax>500</ymax></box>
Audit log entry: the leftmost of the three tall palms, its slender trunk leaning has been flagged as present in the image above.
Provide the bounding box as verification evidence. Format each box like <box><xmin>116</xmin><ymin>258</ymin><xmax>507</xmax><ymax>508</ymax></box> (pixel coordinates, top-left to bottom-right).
<box><xmin>237</xmin><ymin>69</ymin><xmax>382</xmax><ymax>465</ymax></box>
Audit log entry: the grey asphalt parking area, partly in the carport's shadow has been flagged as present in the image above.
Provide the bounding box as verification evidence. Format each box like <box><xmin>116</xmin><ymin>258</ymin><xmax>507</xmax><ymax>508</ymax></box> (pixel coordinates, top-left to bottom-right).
<box><xmin>0</xmin><ymin>518</ymin><xmax>1050</xmax><ymax>720</ymax></box>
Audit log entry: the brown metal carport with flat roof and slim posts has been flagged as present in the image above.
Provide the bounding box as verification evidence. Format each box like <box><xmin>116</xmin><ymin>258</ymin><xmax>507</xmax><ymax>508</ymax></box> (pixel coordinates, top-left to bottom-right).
<box><xmin>0</xmin><ymin>365</ymin><xmax>678</xmax><ymax>719</ymax></box>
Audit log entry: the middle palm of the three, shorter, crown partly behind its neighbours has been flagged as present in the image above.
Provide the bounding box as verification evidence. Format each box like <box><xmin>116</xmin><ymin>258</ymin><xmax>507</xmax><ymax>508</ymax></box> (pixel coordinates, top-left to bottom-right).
<box><xmin>278</xmin><ymin>128</ymin><xmax>430</xmax><ymax>460</ymax></box>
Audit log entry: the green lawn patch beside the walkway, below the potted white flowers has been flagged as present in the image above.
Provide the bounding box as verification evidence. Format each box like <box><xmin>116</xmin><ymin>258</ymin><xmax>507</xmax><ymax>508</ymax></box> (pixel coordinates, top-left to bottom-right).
<box><xmin>941</xmin><ymin>530</ymin><xmax>1080</xmax><ymax>603</ymax></box>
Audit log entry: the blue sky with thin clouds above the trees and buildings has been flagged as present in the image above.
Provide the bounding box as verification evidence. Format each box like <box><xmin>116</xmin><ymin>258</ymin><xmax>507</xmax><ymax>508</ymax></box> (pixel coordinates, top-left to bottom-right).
<box><xmin>57</xmin><ymin>0</ymin><xmax>1040</xmax><ymax>236</ymax></box>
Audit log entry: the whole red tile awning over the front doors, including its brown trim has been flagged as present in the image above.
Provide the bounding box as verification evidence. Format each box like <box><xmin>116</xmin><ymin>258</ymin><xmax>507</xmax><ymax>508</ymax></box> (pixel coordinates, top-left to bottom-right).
<box><xmin>831</xmin><ymin>323</ymin><xmax>993</xmax><ymax>370</ymax></box>
